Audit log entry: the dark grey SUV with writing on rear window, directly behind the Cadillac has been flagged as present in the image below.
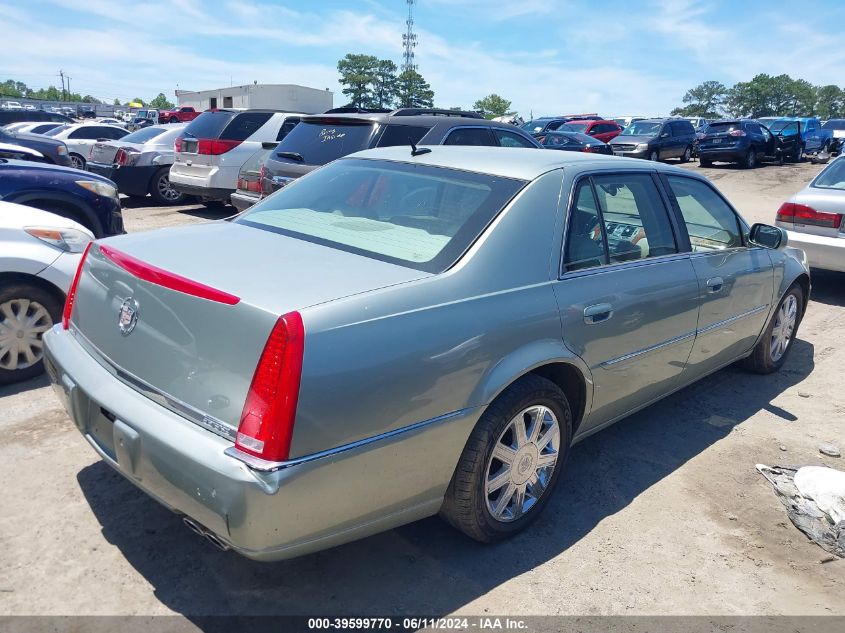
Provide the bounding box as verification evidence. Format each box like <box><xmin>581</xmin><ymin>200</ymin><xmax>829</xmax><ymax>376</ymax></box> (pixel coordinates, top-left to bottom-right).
<box><xmin>261</xmin><ymin>108</ymin><xmax>542</xmax><ymax>195</ymax></box>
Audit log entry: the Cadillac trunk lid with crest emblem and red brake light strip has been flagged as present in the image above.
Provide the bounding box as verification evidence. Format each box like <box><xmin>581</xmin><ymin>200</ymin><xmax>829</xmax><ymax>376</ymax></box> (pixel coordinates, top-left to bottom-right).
<box><xmin>72</xmin><ymin>222</ymin><xmax>426</xmax><ymax>439</ymax></box>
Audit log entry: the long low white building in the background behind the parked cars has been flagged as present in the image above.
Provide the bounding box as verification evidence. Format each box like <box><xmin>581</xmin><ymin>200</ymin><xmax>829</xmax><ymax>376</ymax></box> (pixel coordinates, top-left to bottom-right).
<box><xmin>176</xmin><ymin>83</ymin><xmax>334</xmax><ymax>114</ymax></box>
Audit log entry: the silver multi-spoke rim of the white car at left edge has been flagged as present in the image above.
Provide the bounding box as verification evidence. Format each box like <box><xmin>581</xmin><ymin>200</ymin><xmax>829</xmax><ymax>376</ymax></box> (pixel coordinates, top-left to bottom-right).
<box><xmin>0</xmin><ymin>299</ymin><xmax>53</xmax><ymax>371</ymax></box>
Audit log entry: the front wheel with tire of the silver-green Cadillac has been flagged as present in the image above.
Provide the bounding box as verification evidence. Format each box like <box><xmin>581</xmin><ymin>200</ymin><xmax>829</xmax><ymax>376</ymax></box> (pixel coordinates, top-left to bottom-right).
<box><xmin>742</xmin><ymin>283</ymin><xmax>804</xmax><ymax>374</ymax></box>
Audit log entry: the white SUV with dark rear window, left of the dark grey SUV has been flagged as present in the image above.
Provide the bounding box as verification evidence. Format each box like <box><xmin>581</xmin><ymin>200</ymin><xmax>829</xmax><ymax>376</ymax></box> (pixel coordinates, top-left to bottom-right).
<box><xmin>170</xmin><ymin>109</ymin><xmax>301</xmax><ymax>203</ymax></box>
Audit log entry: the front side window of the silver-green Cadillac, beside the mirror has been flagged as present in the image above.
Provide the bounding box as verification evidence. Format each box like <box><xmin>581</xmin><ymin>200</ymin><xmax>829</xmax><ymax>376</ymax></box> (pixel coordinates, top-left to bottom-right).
<box><xmin>668</xmin><ymin>176</ymin><xmax>742</xmax><ymax>253</ymax></box>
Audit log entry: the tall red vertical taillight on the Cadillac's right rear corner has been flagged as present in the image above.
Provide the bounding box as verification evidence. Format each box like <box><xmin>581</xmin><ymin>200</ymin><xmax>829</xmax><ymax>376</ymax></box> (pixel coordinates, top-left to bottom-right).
<box><xmin>235</xmin><ymin>312</ymin><xmax>305</xmax><ymax>462</ymax></box>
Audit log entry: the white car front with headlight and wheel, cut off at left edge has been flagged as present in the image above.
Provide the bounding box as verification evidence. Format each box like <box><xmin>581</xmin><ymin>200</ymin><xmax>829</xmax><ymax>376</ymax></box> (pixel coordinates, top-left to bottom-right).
<box><xmin>0</xmin><ymin>201</ymin><xmax>94</xmax><ymax>384</ymax></box>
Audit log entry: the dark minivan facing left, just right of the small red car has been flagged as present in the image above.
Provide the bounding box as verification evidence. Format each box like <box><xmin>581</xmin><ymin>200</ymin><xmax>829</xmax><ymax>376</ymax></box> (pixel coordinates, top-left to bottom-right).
<box><xmin>610</xmin><ymin>119</ymin><xmax>696</xmax><ymax>163</ymax></box>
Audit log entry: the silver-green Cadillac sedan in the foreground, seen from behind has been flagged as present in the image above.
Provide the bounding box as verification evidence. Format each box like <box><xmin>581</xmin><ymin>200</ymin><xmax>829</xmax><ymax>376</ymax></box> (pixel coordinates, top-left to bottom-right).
<box><xmin>44</xmin><ymin>147</ymin><xmax>810</xmax><ymax>560</ymax></box>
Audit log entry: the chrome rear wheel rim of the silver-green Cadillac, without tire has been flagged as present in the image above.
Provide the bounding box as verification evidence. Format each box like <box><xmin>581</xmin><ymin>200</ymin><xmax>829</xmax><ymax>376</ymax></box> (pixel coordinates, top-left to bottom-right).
<box><xmin>484</xmin><ymin>405</ymin><xmax>560</xmax><ymax>523</ymax></box>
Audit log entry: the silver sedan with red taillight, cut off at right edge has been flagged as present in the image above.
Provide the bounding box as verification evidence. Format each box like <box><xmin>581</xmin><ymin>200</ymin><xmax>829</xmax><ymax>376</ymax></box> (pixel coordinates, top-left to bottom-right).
<box><xmin>775</xmin><ymin>156</ymin><xmax>845</xmax><ymax>272</ymax></box>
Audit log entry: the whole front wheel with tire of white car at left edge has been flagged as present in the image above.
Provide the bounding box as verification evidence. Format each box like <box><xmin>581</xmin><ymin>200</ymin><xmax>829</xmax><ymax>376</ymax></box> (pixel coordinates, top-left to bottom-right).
<box><xmin>0</xmin><ymin>283</ymin><xmax>63</xmax><ymax>384</ymax></box>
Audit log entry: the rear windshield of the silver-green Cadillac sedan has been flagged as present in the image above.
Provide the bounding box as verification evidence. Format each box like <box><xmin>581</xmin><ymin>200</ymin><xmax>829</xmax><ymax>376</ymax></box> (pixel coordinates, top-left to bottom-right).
<box><xmin>234</xmin><ymin>158</ymin><xmax>526</xmax><ymax>273</ymax></box>
